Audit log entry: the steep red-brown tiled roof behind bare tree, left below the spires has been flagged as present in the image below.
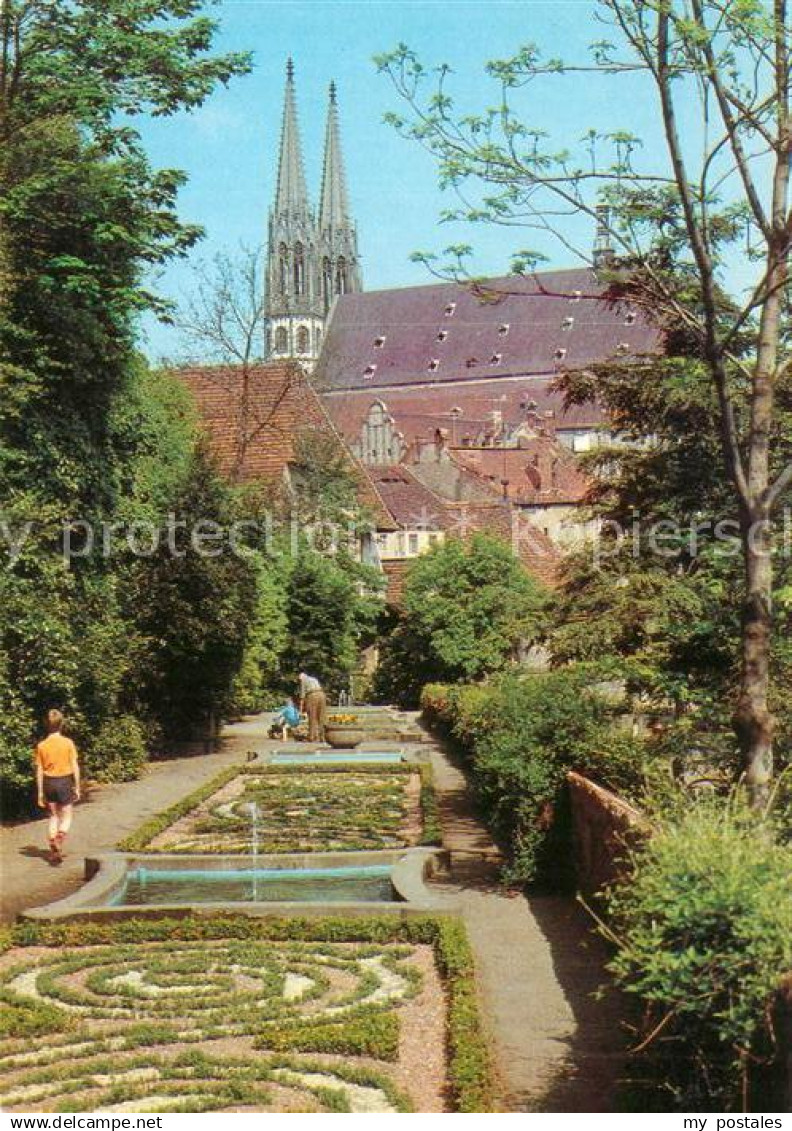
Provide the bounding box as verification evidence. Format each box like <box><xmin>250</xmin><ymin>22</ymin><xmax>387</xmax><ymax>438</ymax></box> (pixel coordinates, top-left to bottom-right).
<box><xmin>174</xmin><ymin>362</ymin><xmax>395</xmax><ymax>529</ymax></box>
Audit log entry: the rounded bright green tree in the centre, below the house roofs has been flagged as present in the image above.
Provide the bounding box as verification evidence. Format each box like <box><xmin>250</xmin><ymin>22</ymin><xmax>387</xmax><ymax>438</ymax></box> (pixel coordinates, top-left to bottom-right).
<box><xmin>397</xmin><ymin>534</ymin><xmax>546</xmax><ymax>682</ymax></box>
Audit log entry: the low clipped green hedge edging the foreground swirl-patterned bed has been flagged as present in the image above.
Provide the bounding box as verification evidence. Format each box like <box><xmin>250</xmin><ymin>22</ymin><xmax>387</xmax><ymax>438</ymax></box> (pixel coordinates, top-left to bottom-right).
<box><xmin>0</xmin><ymin>914</ymin><xmax>496</xmax><ymax>1112</ymax></box>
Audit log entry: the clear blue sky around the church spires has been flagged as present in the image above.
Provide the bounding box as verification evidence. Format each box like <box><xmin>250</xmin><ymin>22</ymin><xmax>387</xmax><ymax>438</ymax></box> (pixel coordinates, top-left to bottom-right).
<box><xmin>139</xmin><ymin>0</ymin><xmax>651</xmax><ymax>360</ymax></box>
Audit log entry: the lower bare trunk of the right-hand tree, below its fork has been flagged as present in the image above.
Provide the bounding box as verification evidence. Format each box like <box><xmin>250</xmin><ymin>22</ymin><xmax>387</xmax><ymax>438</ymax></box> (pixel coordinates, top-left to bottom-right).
<box><xmin>734</xmin><ymin>520</ymin><xmax>775</xmax><ymax>809</ymax></box>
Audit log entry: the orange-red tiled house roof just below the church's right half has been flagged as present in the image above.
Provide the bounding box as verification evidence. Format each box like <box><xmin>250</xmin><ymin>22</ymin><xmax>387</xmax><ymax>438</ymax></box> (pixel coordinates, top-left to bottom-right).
<box><xmin>451</xmin><ymin>437</ymin><xmax>588</xmax><ymax>504</ymax></box>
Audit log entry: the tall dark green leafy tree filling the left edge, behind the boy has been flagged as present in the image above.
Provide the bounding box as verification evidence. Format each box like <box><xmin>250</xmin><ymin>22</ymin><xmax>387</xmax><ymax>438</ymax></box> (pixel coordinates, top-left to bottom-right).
<box><xmin>0</xmin><ymin>0</ymin><xmax>248</xmax><ymax>805</ymax></box>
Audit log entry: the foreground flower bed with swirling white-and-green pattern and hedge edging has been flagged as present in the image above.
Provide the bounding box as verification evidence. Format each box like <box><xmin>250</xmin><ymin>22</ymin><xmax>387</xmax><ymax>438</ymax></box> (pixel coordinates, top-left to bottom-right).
<box><xmin>0</xmin><ymin>918</ymin><xmax>490</xmax><ymax>1113</ymax></box>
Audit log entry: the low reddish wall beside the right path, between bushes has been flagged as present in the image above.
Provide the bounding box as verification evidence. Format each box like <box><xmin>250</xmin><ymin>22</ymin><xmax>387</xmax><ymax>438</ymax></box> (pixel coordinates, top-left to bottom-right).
<box><xmin>567</xmin><ymin>772</ymin><xmax>651</xmax><ymax>896</ymax></box>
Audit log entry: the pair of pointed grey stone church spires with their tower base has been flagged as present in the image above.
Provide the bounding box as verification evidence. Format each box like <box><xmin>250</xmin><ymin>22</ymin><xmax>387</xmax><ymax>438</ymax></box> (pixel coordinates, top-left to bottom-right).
<box><xmin>265</xmin><ymin>59</ymin><xmax>362</xmax><ymax>370</ymax></box>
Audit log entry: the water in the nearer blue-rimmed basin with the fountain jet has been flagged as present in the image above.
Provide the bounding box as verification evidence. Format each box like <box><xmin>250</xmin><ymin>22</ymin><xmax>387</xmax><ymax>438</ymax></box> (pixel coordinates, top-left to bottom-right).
<box><xmin>111</xmin><ymin>864</ymin><xmax>396</xmax><ymax>907</ymax></box>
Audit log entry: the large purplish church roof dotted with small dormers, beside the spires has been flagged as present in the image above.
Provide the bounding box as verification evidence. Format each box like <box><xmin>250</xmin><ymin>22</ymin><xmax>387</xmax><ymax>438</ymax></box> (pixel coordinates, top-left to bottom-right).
<box><xmin>317</xmin><ymin>268</ymin><xmax>660</xmax><ymax>389</ymax></box>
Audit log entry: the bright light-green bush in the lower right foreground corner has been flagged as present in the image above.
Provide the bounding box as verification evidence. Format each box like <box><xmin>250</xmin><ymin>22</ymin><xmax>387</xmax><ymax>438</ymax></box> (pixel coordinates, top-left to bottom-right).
<box><xmin>609</xmin><ymin>800</ymin><xmax>792</xmax><ymax>1111</ymax></box>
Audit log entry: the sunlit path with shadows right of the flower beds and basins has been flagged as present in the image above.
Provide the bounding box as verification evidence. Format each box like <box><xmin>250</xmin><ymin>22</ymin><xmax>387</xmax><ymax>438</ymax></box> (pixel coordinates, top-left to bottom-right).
<box><xmin>432</xmin><ymin>732</ymin><xmax>625</xmax><ymax>1112</ymax></box>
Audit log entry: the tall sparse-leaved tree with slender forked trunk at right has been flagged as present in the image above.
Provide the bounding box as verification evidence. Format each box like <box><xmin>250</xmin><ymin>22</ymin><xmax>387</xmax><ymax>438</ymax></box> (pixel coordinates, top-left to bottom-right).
<box><xmin>378</xmin><ymin>0</ymin><xmax>792</xmax><ymax>804</ymax></box>
